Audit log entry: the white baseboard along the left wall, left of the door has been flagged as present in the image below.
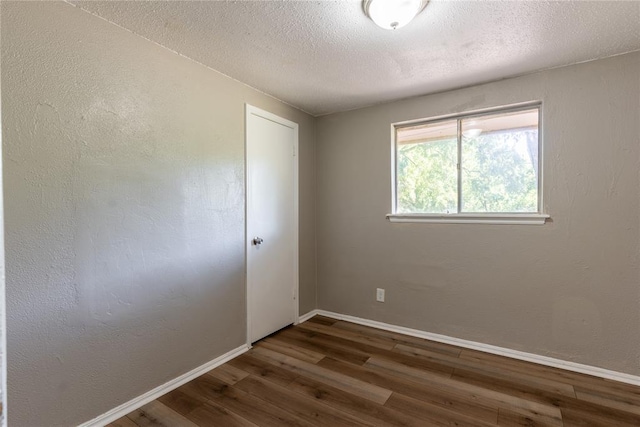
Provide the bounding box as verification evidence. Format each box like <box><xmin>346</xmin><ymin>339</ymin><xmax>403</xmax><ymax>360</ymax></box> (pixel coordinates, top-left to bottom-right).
<box><xmin>79</xmin><ymin>344</ymin><xmax>249</xmax><ymax>427</ymax></box>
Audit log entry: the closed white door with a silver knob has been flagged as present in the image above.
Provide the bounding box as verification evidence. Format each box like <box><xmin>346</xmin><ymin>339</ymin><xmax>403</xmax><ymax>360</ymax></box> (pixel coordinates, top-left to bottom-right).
<box><xmin>246</xmin><ymin>105</ymin><xmax>298</xmax><ymax>343</ymax></box>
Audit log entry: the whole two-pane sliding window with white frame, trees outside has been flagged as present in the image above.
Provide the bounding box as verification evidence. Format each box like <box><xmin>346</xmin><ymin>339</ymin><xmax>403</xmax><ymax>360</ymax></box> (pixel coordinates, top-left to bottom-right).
<box><xmin>389</xmin><ymin>105</ymin><xmax>548</xmax><ymax>223</ymax></box>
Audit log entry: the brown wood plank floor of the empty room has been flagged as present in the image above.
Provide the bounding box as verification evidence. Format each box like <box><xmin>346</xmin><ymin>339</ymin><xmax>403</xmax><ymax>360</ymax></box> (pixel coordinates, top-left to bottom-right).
<box><xmin>111</xmin><ymin>316</ymin><xmax>640</xmax><ymax>427</ymax></box>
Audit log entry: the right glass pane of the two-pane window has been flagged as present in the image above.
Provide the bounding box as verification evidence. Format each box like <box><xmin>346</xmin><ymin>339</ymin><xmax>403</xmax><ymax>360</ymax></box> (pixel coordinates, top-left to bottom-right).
<box><xmin>461</xmin><ymin>108</ymin><xmax>538</xmax><ymax>213</ymax></box>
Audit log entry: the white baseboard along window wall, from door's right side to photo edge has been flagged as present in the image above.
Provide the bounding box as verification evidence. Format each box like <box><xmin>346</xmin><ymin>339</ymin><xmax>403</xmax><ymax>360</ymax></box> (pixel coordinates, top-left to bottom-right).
<box><xmin>298</xmin><ymin>310</ymin><xmax>640</xmax><ymax>385</ymax></box>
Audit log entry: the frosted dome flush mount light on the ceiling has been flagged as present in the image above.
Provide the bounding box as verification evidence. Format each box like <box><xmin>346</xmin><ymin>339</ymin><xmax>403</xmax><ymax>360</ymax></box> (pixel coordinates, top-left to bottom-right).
<box><xmin>362</xmin><ymin>0</ymin><xmax>429</xmax><ymax>30</ymax></box>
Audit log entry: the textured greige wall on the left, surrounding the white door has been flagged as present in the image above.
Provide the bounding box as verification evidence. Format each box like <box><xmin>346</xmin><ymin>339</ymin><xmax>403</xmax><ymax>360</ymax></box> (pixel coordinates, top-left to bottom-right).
<box><xmin>2</xmin><ymin>2</ymin><xmax>315</xmax><ymax>427</ymax></box>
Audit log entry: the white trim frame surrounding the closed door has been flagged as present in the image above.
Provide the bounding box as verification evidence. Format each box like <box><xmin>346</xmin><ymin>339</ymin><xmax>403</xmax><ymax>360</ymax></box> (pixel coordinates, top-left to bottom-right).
<box><xmin>244</xmin><ymin>103</ymin><xmax>300</xmax><ymax>348</ymax></box>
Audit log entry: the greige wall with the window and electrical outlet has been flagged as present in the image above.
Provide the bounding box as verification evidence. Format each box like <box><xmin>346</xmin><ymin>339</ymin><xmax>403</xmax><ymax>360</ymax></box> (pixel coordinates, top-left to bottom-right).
<box><xmin>317</xmin><ymin>53</ymin><xmax>640</xmax><ymax>375</ymax></box>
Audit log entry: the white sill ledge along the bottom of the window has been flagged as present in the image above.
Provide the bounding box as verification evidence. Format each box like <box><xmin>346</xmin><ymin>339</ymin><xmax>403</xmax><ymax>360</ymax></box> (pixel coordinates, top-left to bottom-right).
<box><xmin>387</xmin><ymin>213</ymin><xmax>549</xmax><ymax>225</ymax></box>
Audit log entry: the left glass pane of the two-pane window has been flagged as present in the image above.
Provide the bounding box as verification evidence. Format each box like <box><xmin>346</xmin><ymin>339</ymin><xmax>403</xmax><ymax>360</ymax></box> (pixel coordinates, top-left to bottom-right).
<box><xmin>396</xmin><ymin>120</ymin><xmax>458</xmax><ymax>213</ymax></box>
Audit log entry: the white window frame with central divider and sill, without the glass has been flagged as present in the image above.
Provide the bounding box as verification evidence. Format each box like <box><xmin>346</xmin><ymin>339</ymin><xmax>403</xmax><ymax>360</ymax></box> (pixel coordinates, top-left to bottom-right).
<box><xmin>387</xmin><ymin>101</ymin><xmax>550</xmax><ymax>225</ymax></box>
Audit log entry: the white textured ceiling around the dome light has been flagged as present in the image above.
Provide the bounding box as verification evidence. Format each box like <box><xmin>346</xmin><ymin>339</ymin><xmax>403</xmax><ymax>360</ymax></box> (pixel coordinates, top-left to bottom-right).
<box><xmin>72</xmin><ymin>0</ymin><xmax>640</xmax><ymax>115</ymax></box>
